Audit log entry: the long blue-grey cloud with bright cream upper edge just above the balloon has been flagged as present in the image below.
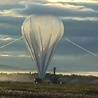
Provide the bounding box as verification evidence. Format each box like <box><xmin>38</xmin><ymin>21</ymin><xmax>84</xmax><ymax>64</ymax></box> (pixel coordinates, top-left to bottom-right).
<box><xmin>17</xmin><ymin>3</ymin><xmax>98</xmax><ymax>17</ymax></box>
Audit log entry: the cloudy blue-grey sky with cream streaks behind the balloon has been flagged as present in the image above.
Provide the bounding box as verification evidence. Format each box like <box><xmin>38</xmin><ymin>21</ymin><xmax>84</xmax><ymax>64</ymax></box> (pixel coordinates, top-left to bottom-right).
<box><xmin>0</xmin><ymin>0</ymin><xmax>98</xmax><ymax>74</ymax></box>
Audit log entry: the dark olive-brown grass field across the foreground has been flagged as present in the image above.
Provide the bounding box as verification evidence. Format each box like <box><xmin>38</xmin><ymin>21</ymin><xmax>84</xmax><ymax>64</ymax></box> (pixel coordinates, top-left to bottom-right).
<box><xmin>0</xmin><ymin>82</ymin><xmax>98</xmax><ymax>98</ymax></box>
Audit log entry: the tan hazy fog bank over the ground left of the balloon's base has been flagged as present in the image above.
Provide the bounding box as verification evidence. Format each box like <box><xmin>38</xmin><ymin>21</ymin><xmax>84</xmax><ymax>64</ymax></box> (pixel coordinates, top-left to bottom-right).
<box><xmin>0</xmin><ymin>73</ymin><xmax>37</xmax><ymax>82</ymax></box>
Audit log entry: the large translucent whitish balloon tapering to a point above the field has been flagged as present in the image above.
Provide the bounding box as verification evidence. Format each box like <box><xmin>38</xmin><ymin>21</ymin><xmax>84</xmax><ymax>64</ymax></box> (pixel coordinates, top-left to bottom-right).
<box><xmin>22</xmin><ymin>14</ymin><xmax>64</xmax><ymax>79</ymax></box>
